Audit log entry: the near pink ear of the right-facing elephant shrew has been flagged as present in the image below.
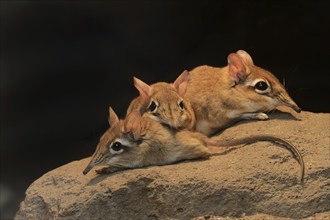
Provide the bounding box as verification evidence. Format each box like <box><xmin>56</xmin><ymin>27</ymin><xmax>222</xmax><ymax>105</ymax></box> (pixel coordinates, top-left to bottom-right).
<box><xmin>227</xmin><ymin>53</ymin><xmax>250</xmax><ymax>84</ymax></box>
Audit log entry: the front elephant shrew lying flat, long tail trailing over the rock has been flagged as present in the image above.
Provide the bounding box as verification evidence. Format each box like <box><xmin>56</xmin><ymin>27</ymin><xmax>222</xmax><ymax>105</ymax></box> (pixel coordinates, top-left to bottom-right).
<box><xmin>83</xmin><ymin>108</ymin><xmax>304</xmax><ymax>181</ymax></box>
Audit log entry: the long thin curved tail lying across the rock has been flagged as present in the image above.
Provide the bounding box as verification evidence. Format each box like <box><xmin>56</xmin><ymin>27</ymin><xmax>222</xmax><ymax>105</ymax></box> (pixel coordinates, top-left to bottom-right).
<box><xmin>210</xmin><ymin>135</ymin><xmax>305</xmax><ymax>184</ymax></box>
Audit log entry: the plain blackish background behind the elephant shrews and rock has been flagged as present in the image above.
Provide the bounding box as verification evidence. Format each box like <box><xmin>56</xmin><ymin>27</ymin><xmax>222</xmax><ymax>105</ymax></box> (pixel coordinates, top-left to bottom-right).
<box><xmin>0</xmin><ymin>0</ymin><xmax>330</xmax><ymax>219</ymax></box>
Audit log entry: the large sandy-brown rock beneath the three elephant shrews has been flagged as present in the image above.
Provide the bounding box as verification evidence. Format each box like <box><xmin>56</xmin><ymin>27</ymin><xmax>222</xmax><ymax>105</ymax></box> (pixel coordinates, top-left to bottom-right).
<box><xmin>15</xmin><ymin>112</ymin><xmax>330</xmax><ymax>220</ymax></box>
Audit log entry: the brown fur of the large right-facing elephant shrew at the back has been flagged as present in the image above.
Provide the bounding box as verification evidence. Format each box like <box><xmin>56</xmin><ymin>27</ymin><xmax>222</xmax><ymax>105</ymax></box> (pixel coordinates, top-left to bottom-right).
<box><xmin>185</xmin><ymin>50</ymin><xmax>300</xmax><ymax>135</ymax></box>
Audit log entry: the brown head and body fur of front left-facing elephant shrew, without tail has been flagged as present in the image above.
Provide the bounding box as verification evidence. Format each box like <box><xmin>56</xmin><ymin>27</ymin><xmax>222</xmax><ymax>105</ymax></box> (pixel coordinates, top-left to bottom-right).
<box><xmin>84</xmin><ymin>108</ymin><xmax>214</xmax><ymax>174</ymax></box>
